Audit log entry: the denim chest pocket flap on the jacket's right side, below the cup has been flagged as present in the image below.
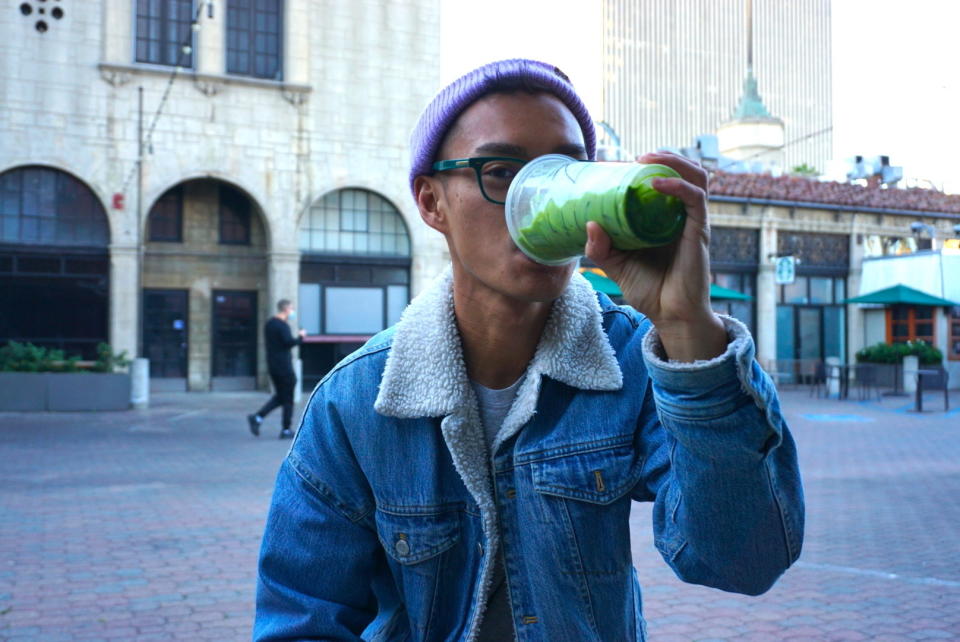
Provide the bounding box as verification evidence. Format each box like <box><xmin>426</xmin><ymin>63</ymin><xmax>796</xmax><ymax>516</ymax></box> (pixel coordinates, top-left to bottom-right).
<box><xmin>531</xmin><ymin>443</ymin><xmax>643</xmax><ymax>504</ymax></box>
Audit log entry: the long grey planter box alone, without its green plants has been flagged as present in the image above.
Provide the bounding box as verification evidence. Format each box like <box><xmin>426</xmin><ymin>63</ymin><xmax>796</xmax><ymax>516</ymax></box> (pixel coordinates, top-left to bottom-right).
<box><xmin>0</xmin><ymin>372</ymin><xmax>130</xmax><ymax>411</ymax></box>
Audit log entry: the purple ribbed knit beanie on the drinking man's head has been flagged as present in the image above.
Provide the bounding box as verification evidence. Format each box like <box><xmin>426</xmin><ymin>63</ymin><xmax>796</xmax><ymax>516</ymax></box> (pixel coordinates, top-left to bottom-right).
<box><xmin>410</xmin><ymin>58</ymin><xmax>597</xmax><ymax>191</ymax></box>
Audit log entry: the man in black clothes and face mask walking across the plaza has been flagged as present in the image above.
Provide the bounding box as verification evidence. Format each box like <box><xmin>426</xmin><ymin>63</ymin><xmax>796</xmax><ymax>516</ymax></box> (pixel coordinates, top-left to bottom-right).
<box><xmin>247</xmin><ymin>299</ymin><xmax>306</xmax><ymax>439</ymax></box>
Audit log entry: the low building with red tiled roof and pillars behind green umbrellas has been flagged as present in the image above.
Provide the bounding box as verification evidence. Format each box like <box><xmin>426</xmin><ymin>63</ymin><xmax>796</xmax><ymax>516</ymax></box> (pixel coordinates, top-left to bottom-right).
<box><xmin>710</xmin><ymin>172</ymin><xmax>960</xmax><ymax>387</ymax></box>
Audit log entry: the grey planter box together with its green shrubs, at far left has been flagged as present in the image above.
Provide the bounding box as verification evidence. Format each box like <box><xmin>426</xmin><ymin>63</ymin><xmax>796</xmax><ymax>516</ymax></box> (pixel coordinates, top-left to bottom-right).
<box><xmin>0</xmin><ymin>341</ymin><xmax>130</xmax><ymax>411</ymax></box>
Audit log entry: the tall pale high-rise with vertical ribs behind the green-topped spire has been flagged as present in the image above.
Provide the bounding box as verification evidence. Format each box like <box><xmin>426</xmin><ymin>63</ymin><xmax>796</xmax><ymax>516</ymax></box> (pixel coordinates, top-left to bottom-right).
<box><xmin>602</xmin><ymin>0</ymin><xmax>832</xmax><ymax>171</ymax></box>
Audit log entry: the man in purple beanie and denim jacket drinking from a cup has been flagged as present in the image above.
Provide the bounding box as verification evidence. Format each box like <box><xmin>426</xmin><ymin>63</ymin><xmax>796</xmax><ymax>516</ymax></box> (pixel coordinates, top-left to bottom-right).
<box><xmin>254</xmin><ymin>60</ymin><xmax>803</xmax><ymax>640</ymax></box>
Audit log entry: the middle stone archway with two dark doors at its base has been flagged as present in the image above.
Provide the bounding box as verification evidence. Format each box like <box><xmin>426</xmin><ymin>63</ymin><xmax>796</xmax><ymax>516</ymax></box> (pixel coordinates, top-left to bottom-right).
<box><xmin>142</xmin><ymin>179</ymin><xmax>267</xmax><ymax>390</ymax></box>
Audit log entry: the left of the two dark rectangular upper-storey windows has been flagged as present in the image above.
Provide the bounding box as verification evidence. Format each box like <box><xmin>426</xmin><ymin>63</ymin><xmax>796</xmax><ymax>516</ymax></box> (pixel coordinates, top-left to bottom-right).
<box><xmin>137</xmin><ymin>0</ymin><xmax>194</xmax><ymax>67</ymax></box>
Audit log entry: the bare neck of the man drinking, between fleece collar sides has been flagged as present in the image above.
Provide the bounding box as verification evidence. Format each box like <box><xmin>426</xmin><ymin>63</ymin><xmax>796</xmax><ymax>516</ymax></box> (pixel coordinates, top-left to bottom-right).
<box><xmin>453</xmin><ymin>284</ymin><xmax>553</xmax><ymax>389</ymax></box>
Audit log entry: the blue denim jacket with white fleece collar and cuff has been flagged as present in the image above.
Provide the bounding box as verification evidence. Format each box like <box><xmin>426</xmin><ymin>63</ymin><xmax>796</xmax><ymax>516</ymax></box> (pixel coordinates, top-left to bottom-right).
<box><xmin>254</xmin><ymin>271</ymin><xmax>804</xmax><ymax>640</ymax></box>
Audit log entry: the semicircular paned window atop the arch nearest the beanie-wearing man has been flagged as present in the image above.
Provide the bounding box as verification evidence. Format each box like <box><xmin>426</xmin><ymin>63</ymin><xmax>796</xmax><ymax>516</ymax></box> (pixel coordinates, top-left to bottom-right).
<box><xmin>300</xmin><ymin>189</ymin><xmax>410</xmax><ymax>257</ymax></box>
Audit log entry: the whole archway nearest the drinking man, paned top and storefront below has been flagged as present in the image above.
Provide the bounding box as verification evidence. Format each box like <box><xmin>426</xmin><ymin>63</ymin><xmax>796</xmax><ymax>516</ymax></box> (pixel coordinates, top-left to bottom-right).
<box><xmin>299</xmin><ymin>188</ymin><xmax>410</xmax><ymax>387</ymax></box>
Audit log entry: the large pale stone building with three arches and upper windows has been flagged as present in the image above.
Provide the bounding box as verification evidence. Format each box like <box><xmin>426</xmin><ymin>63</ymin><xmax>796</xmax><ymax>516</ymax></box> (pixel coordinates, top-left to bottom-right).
<box><xmin>0</xmin><ymin>0</ymin><xmax>445</xmax><ymax>390</ymax></box>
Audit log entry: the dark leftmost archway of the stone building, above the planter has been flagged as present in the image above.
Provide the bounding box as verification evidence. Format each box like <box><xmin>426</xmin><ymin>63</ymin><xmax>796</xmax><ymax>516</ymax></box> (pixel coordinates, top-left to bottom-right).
<box><xmin>0</xmin><ymin>165</ymin><xmax>110</xmax><ymax>359</ymax></box>
